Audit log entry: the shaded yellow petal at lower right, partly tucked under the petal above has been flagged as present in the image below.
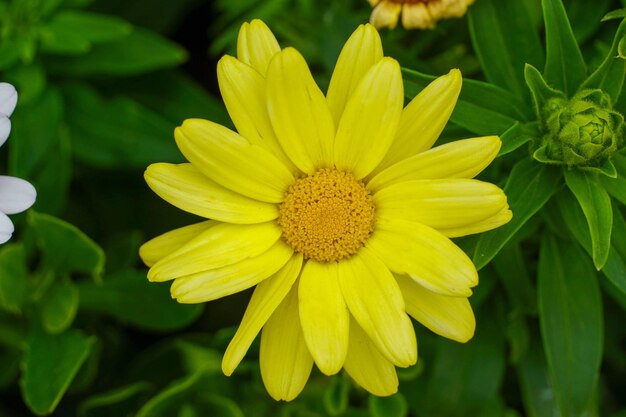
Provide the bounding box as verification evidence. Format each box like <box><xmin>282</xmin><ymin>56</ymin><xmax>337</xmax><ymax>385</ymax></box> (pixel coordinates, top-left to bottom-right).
<box><xmin>396</xmin><ymin>275</ymin><xmax>476</xmax><ymax>343</ymax></box>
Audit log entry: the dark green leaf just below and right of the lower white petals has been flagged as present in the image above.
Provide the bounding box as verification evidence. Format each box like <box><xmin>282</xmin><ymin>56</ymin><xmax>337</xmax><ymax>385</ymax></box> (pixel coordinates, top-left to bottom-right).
<box><xmin>28</xmin><ymin>210</ymin><xmax>104</xmax><ymax>277</ymax></box>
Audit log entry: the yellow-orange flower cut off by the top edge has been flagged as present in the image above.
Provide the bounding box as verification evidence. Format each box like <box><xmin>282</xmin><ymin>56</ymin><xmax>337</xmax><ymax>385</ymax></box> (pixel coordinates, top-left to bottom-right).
<box><xmin>368</xmin><ymin>0</ymin><xmax>474</xmax><ymax>29</ymax></box>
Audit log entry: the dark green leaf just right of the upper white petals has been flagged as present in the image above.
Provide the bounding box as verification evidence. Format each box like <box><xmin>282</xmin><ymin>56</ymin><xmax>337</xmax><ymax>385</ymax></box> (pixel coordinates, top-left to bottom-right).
<box><xmin>9</xmin><ymin>88</ymin><xmax>63</xmax><ymax>178</ymax></box>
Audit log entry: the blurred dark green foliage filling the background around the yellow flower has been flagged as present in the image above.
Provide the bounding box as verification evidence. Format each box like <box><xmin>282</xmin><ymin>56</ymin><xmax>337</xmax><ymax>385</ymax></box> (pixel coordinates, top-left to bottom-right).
<box><xmin>0</xmin><ymin>0</ymin><xmax>626</xmax><ymax>417</ymax></box>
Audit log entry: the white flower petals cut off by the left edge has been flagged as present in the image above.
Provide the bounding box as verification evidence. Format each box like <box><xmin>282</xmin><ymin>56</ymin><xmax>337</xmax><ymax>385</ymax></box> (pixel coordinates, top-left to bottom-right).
<box><xmin>0</xmin><ymin>82</ymin><xmax>37</xmax><ymax>243</ymax></box>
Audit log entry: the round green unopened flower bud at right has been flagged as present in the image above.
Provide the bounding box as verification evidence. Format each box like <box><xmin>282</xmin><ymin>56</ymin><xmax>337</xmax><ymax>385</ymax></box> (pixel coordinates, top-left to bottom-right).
<box><xmin>533</xmin><ymin>90</ymin><xmax>624</xmax><ymax>167</ymax></box>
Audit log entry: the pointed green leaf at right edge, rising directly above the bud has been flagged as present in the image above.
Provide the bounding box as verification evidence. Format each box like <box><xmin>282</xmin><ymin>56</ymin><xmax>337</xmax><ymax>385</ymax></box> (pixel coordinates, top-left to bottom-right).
<box><xmin>581</xmin><ymin>19</ymin><xmax>626</xmax><ymax>103</ymax></box>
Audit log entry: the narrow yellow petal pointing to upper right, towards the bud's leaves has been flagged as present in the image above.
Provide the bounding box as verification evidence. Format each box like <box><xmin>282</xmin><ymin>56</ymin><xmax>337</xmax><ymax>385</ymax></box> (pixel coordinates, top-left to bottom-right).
<box><xmin>377</xmin><ymin>69</ymin><xmax>462</xmax><ymax>171</ymax></box>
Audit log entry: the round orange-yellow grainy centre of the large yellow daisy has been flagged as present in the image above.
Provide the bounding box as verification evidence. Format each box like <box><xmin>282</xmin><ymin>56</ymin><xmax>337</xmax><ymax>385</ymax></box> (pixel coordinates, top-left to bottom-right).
<box><xmin>278</xmin><ymin>168</ymin><xmax>375</xmax><ymax>262</ymax></box>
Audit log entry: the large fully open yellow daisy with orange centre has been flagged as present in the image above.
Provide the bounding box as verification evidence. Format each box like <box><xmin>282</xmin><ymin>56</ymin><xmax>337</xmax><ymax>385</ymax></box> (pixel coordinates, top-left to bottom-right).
<box><xmin>140</xmin><ymin>20</ymin><xmax>511</xmax><ymax>400</ymax></box>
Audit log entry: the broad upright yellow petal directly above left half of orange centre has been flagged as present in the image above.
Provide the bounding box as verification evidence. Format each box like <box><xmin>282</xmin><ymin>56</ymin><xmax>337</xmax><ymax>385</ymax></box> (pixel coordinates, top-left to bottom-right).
<box><xmin>267</xmin><ymin>48</ymin><xmax>335</xmax><ymax>174</ymax></box>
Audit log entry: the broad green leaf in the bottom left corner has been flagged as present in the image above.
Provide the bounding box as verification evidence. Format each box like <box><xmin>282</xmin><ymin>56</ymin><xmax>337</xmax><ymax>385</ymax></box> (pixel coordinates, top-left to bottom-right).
<box><xmin>20</xmin><ymin>328</ymin><xmax>93</xmax><ymax>415</ymax></box>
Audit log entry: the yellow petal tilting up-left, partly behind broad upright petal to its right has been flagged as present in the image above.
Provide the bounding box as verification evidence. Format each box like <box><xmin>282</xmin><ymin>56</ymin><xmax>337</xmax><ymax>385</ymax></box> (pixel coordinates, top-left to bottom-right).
<box><xmin>217</xmin><ymin>55</ymin><xmax>296</xmax><ymax>172</ymax></box>
